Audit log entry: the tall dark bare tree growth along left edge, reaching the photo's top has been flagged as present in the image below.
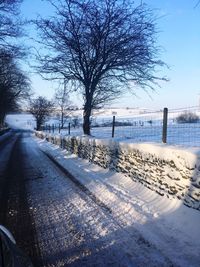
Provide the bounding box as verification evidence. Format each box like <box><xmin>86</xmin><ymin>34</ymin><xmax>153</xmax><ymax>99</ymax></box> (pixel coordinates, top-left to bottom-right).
<box><xmin>0</xmin><ymin>0</ymin><xmax>30</xmax><ymax>129</ymax></box>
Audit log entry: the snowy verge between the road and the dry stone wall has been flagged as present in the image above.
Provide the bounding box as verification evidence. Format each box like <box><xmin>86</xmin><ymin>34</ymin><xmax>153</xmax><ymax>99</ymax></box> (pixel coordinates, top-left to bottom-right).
<box><xmin>35</xmin><ymin>138</ymin><xmax>200</xmax><ymax>267</ymax></box>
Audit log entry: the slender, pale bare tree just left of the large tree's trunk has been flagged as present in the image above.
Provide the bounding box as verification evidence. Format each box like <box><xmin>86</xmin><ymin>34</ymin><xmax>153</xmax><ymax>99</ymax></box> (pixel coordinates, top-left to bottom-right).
<box><xmin>54</xmin><ymin>80</ymin><xmax>72</xmax><ymax>129</ymax></box>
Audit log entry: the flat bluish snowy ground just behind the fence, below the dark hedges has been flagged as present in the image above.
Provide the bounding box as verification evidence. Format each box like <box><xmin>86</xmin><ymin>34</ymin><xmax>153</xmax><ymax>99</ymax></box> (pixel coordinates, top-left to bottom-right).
<box><xmin>50</xmin><ymin>123</ymin><xmax>200</xmax><ymax>147</ymax></box>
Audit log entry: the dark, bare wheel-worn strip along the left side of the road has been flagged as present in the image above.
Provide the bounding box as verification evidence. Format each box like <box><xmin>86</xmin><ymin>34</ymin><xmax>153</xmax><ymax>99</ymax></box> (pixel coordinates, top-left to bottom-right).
<box><xmin>0</xmin><ymin>134</ymin><xmax>42</xmax><ymax>266</ymax></box>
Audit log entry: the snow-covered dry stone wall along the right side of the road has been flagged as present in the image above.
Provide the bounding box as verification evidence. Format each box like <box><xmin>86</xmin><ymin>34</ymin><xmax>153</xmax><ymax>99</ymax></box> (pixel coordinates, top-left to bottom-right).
<box><xmin>36</xmin><ymin>132</ymin><xmax>200</xmax><ymax>210</ymax></box>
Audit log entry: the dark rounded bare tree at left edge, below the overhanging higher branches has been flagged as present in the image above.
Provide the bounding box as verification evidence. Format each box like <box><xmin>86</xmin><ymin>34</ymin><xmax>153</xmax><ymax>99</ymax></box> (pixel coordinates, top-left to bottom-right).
<box><xmin>0</xmin><ymin>49</ymin><xmax>30</xmax><ymax>126</ymax></box>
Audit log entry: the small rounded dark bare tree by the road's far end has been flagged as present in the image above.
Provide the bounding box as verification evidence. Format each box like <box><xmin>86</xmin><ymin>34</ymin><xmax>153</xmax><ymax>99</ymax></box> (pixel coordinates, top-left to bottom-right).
<box><xmin>30</xmin><ymin>96</ymin><xmax>53</xmax><ymax>130</ymax></box>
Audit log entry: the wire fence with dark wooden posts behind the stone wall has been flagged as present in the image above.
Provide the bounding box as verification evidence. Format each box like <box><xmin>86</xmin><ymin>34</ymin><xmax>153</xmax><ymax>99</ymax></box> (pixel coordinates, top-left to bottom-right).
<box><xmin>43</xmin><ymin>107</ymin><xmax>200</xmax><ymax>146</ymax></box>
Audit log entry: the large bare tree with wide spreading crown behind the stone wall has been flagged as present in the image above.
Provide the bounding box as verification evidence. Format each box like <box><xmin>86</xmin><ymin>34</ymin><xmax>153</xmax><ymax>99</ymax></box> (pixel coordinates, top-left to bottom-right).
<box><xmin>36</xmin><ymin>0</ymin><xmax>164</xmax><ymax>134</ymax></box>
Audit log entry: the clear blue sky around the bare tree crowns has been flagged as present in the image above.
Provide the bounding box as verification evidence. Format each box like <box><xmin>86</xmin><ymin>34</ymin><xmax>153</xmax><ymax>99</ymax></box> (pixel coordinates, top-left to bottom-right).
<box><xmin>21</xmin><ymin>0</ymin><xmax>200</xmax><ymax>109</ymax></box>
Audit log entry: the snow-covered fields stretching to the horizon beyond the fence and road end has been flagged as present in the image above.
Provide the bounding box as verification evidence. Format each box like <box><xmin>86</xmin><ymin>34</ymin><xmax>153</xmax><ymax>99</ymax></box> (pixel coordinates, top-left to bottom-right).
<box><xmin>6</xmin><ymin>108</ymin><xmax>200</xmax><ymax>147</ymax></box>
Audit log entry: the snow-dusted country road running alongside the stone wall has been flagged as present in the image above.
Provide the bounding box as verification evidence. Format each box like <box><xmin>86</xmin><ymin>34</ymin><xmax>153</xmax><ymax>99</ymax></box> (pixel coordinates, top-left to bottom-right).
<box><xmin>0</xmin><ymin>131</ymin><xmax>174</xmax><ymax>267</ymax></box>
